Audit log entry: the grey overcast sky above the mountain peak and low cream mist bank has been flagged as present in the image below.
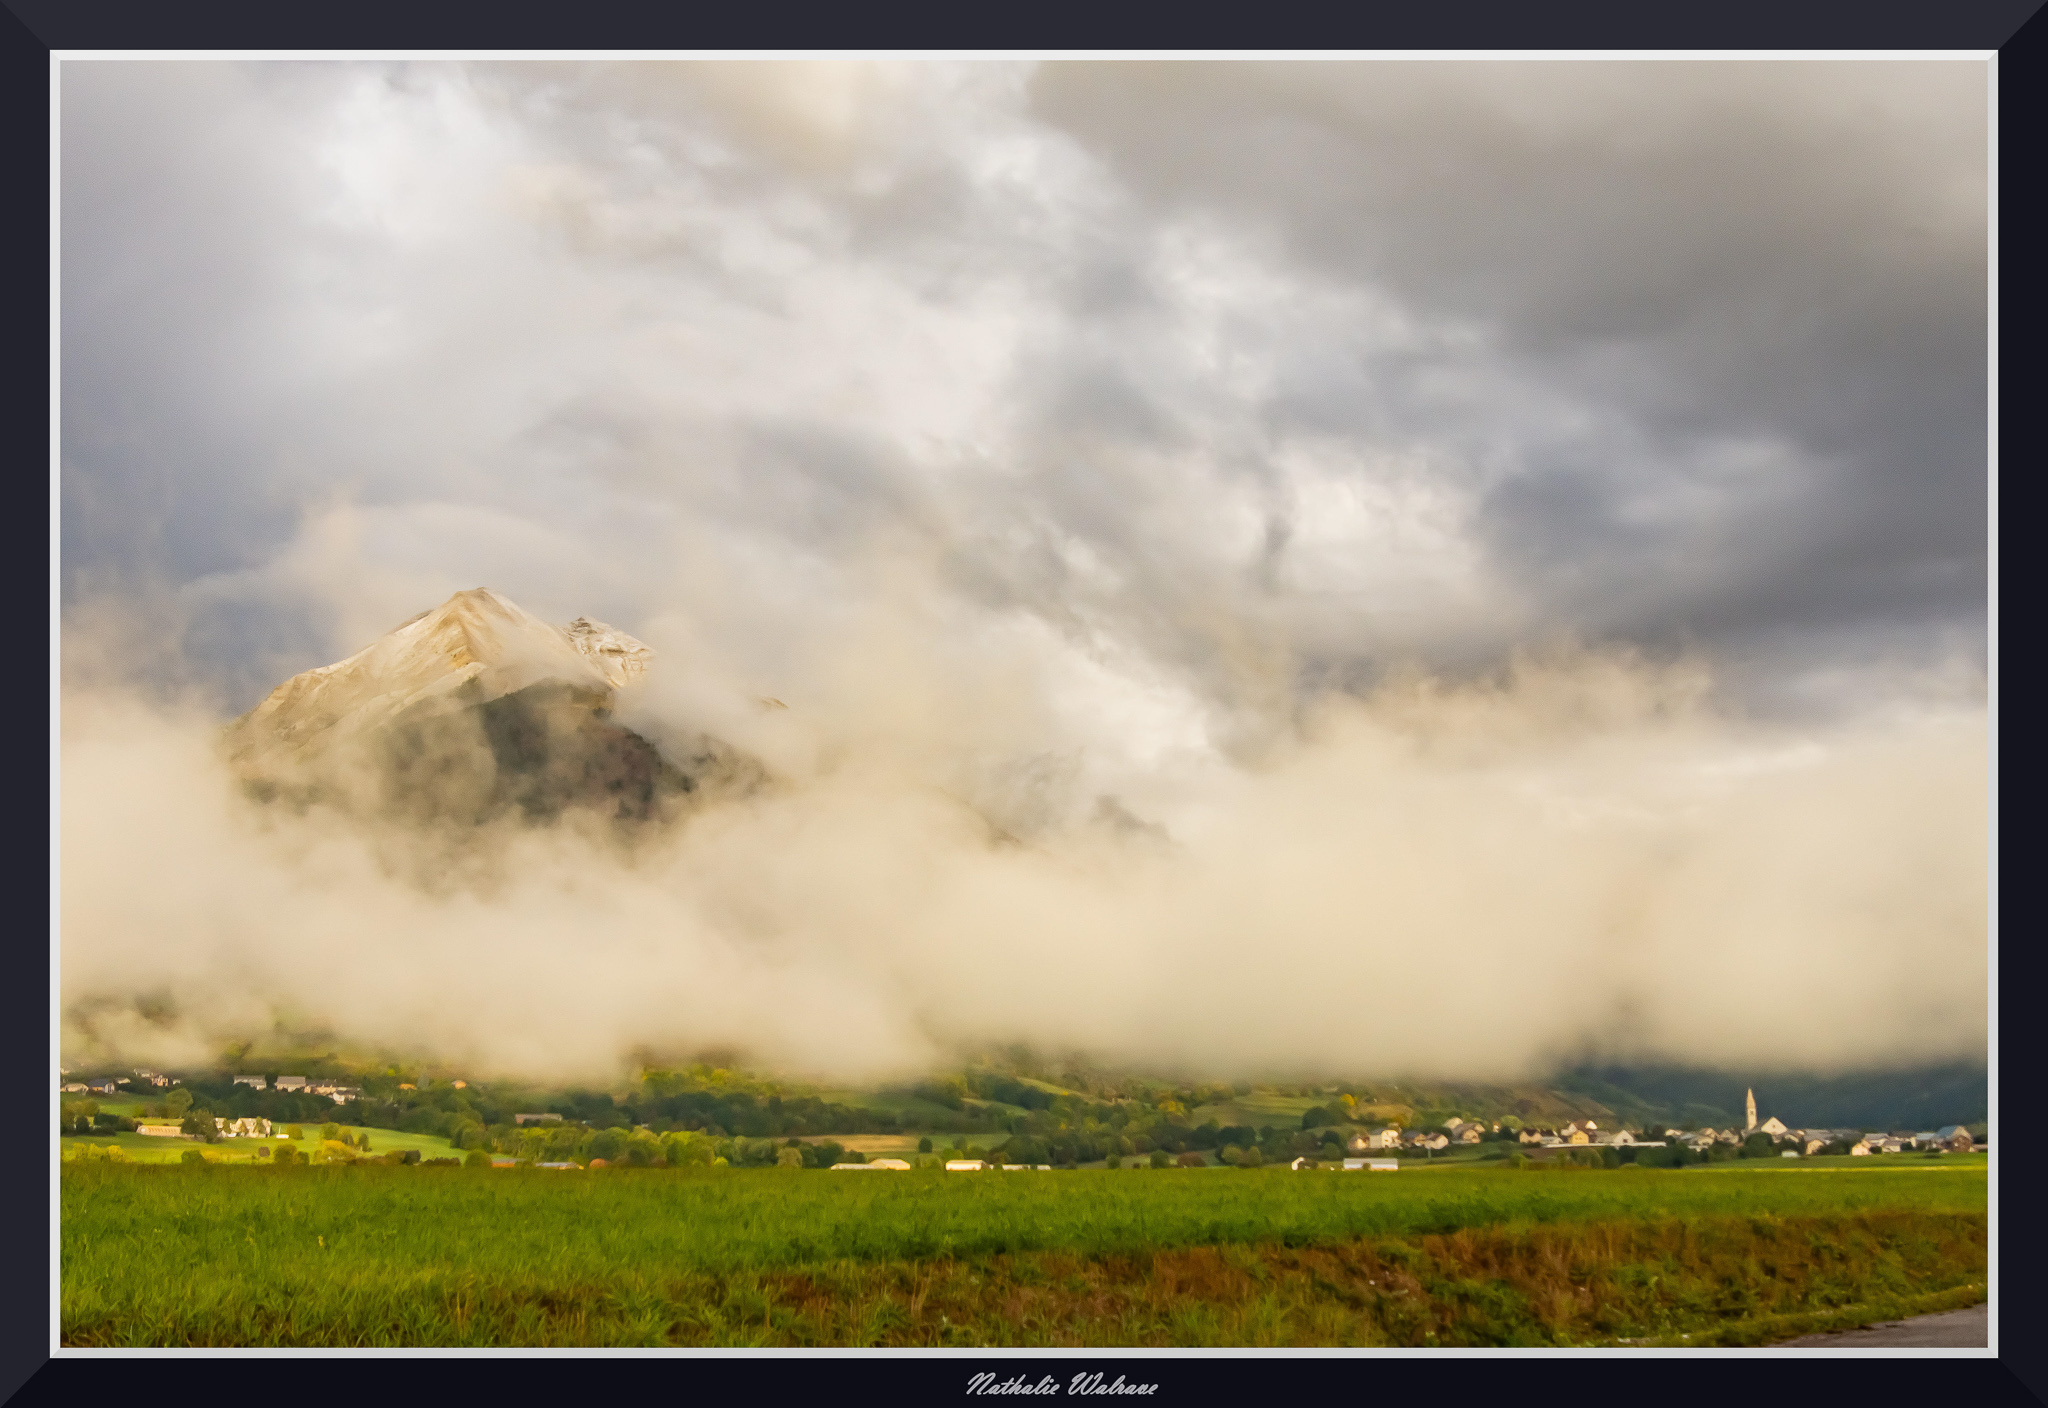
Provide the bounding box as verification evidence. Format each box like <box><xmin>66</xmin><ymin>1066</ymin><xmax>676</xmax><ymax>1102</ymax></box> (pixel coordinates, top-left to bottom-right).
<box><xmin>61</xmin><ymin>61</ymin><xmax>1987</xmax><ymax>732</ymax></box>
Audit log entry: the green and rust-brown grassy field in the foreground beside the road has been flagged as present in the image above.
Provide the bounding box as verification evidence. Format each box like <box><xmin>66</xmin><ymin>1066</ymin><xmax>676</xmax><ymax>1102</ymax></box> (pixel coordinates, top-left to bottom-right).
<box><xmin>61</xmin><ymin>1160</ymin><xmax>1987</xmax><ymax>1345</ymax></box>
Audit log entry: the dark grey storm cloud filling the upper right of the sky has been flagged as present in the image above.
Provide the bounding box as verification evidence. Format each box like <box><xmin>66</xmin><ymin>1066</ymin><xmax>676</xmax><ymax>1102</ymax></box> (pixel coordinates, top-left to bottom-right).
<box><xmin>1032</xmin><ymin>63</ymin><xmax>1987</xmax><ymax>704</ymax></box>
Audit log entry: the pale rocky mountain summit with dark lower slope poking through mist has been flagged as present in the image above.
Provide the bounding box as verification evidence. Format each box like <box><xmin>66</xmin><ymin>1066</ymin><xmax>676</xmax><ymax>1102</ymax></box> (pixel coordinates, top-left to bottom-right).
<box><xmin>225</xmin><ymin>587</ymin><xmax>758</xmax><ymax>825</ymax></box>
